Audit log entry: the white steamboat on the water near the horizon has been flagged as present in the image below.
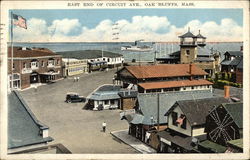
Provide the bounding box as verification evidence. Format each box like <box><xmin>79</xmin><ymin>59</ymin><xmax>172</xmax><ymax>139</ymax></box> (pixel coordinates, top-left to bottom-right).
<box><xmin>121</xmin><ymin>40</ymin><xmax>153</xmax><ymax>52</ymax></box>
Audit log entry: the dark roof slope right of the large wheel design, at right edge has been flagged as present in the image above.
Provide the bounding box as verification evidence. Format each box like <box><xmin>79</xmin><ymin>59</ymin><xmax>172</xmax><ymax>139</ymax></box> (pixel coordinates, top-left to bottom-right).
<box><xmin>222</xmin><ymin>103</ymin><xmax>243</xmax><ymax>128</ymax></box>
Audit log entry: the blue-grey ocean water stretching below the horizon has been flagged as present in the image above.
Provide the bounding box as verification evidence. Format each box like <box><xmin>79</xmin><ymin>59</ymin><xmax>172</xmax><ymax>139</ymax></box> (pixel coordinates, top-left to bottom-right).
<box><xmin>14</xmin><ymin>42</ymin><xmax>243</xmax><ymax>62</ymax></box>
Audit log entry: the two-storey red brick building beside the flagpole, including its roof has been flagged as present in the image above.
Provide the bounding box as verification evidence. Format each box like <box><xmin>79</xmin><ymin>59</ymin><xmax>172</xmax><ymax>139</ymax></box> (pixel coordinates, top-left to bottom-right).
<box><xmin>8</xmin><ymin>47</ymin><xmax>62</xmax><ymax>89</ymax></box>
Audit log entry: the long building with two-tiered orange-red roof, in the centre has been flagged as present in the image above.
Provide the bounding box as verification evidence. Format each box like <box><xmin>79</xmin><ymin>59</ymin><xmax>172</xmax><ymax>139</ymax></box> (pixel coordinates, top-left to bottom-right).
<box><xmin>115</xmin><ymin>64</ymin><xmax>212</xmax><ymax>93</ymax></box>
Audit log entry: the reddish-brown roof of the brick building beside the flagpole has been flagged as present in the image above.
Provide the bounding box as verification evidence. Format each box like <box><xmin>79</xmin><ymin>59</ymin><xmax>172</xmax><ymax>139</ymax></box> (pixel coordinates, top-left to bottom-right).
<box><xmin>8</xmin><ymin>47</ymin><xmax>59</xmax><ymax>58</ymax></box>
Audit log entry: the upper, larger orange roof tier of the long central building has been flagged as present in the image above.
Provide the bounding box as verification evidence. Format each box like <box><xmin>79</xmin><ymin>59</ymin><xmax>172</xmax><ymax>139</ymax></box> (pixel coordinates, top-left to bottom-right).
<box><xmin>126</xmin><ymin>64</ymin><xmax>207</xmax><ymax>79</ymax></box>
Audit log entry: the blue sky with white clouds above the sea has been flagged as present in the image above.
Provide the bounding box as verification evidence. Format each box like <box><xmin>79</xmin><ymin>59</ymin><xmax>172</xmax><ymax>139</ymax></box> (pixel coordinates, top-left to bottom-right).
<box><xmin>13</xmin><ymin>9</ymin><xmax>243</xmax><ymax>42</ymax></box>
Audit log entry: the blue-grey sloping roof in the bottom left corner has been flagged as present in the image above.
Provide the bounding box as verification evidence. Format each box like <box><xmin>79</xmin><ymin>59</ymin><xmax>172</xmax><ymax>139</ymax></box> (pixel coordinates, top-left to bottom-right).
<box><xmin>8</xmin><ymin>91</ymin><xmax>53</xmax><ymax>149</ymax></box>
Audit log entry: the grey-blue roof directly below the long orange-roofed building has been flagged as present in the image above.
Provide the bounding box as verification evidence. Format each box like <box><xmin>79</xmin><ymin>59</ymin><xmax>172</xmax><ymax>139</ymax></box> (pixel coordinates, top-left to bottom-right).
<box><xmin>134</xmin><ymin>90</ymin><xmax>213</xmax><ymax>125</ymax></box>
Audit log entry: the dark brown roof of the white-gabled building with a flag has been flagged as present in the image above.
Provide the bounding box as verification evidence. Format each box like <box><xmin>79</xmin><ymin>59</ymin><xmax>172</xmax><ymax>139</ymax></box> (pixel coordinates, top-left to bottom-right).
<box><xmin>166</xmin><ymin>97</ymin><xmax>228</xmax><ymax>126</ymax></box>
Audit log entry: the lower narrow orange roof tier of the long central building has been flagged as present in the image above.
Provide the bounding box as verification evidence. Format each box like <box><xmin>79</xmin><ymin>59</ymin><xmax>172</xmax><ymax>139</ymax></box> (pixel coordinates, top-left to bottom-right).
<box><xmin>138</xmin><ymin>79</ymin><xmax>213</xmax><ymax>89</ymax></box>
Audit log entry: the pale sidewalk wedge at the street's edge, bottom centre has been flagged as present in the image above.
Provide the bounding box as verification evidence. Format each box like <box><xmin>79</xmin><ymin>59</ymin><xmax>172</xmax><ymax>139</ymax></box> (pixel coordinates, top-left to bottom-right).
<box><xmin>111</xmin><ymin>130</ymin><xmax>156</xmax><ymax>154</ymax></box>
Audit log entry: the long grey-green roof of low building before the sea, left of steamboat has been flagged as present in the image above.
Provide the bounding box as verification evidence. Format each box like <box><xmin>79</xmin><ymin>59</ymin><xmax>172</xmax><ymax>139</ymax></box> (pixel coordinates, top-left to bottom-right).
<box><xmin>57</xmin><ymin>50</ymin><xmax>122</xmax><ymax>59</ymax></box>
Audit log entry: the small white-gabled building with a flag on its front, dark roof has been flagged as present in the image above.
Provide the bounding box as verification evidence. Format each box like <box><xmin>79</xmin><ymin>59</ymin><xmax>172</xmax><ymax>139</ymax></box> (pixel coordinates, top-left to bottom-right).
<box><xmin>159</xmin><ymin>97</ymin><xmax>228</xmax><ymax>153</ymax></box>
